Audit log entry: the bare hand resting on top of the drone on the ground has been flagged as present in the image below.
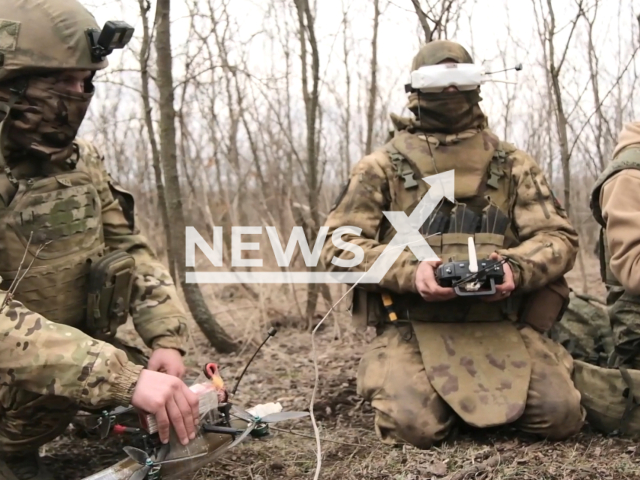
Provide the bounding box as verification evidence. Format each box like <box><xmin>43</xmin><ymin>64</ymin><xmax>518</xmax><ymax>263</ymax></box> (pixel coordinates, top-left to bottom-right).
<box><xmin>131</xmin><ymin>370</ymin><xmax>199</xmax><ymax>445</ymax></box>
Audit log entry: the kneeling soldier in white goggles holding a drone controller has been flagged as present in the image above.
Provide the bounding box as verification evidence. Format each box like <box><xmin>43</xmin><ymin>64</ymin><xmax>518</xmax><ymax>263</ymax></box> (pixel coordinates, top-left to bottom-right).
<box><xmin>322</xmin><ymin>41</ymin><xmax>585</xmax><ymax>448</ymax></box>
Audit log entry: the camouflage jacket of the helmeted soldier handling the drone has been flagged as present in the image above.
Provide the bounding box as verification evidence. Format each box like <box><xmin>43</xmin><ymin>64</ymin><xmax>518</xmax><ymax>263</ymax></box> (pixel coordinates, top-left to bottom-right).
<box><xmin>0</xmin><ymin>136</ymin><xmax>188</xmax><ymax>404</ymax></box>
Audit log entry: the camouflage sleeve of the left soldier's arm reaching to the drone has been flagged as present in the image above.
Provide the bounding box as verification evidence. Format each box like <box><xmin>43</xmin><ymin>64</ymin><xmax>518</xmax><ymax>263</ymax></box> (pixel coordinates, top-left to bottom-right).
<box><xmin>0</xmin><ymin>293</ymin><xmax>143</xmax><ymax>407</ymax></box>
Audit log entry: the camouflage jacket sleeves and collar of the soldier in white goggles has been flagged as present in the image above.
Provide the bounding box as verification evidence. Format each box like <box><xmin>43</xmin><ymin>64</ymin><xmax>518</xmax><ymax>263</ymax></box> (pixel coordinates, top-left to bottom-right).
<box><xmin>322</xmin><ymin>125</ymin><xmax>578</xmax><ymax>294</ymax></box>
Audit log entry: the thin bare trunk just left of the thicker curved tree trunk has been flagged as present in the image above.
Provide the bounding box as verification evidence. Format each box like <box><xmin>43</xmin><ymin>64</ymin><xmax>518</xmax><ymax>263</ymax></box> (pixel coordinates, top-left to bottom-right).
<box><xmin>138</xmin><ymin>0</ymin><xmax>178</xmax><ymax>281</ymax></box>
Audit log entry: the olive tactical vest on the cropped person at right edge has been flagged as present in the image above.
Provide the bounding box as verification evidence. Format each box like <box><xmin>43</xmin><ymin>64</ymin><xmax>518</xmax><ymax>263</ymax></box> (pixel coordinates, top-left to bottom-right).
<box><xmin>590</xmin><ymin>145</ymin><xmax>640</xmax><ymax>362</ymax></box>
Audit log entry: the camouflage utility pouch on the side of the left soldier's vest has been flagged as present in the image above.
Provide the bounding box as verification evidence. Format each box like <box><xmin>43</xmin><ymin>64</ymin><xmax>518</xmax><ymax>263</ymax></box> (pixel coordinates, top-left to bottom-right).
<box><xmin>87</xmin><ymin>251</ymin><xmax>135</xmax><ymax>339</ymax></box>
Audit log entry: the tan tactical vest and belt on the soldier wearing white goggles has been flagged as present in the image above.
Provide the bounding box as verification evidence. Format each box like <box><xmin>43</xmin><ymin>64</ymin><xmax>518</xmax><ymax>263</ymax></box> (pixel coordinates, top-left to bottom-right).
<box><xmin>352</xmin><ymin>129</ymin><xmax>523</xmax><ymax>327</ymax></box>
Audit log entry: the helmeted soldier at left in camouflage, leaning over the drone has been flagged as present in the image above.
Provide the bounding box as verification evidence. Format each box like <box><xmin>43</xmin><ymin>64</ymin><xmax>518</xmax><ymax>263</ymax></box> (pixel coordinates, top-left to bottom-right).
<box><xmin>0</xmin><ymin>0</ymin><xmax>187</xmax><ymax>458</ymax></box>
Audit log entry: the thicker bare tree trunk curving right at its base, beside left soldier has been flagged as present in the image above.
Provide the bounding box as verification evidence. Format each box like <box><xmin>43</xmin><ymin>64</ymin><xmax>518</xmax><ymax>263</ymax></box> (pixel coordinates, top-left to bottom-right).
<box><xmin>156</xmin><ymin>0</ymin><xmax>238</xmax><ymax>353</ymax></box>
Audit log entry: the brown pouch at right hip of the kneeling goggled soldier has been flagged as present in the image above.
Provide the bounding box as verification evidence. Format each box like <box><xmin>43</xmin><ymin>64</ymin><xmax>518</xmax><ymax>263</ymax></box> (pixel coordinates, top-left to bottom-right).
<box><xmin>520</xmin><ymin>277</ymin><xmax>571</xmax><ymax>333</ymax></box>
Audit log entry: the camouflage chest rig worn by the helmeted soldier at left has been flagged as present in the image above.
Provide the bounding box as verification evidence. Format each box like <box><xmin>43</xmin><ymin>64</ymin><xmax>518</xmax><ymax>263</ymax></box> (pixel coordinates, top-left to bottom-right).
<box><xmin>0</xmin><ymin>144</ymin><xmax>126</xmax><ymax>331</ymax></box>
